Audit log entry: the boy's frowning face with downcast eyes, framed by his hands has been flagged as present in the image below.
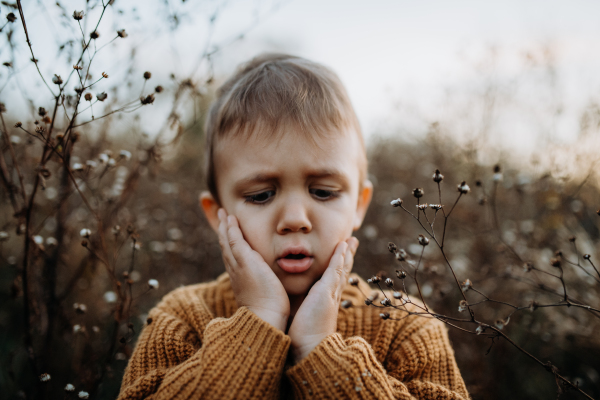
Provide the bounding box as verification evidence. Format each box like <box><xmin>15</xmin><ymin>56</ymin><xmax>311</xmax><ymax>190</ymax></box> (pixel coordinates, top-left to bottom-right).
<box><xmin>203</xmin><ymin>128</ymin><xmax>372</xmax><ymax>295</ymax></box>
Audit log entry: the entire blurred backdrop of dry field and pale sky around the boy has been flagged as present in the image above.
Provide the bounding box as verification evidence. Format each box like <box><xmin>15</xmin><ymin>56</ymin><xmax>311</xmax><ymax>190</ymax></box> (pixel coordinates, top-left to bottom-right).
<box><xmin>0</xmin><ymin>0</ymin><xmax>600</xmax><ymax>399</ymax></box>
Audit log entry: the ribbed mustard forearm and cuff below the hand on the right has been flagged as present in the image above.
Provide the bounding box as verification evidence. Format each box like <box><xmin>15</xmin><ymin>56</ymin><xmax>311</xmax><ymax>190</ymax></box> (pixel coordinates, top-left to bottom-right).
<box><xmin>286</xmin><ymin>333</ymin><xmax>404</xmax><ymax>399</ymax></box>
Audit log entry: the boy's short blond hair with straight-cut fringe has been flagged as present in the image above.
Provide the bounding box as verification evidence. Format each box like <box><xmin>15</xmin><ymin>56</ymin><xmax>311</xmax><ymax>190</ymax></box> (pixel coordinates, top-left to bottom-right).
<box><xmin>204</xmin><ymin>53</ymin><xmax>367</xmax><ymax>202</ymax></box>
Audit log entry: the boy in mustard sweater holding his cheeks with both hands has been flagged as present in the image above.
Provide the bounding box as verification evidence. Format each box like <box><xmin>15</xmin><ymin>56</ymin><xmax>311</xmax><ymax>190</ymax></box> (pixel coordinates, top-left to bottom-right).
<box><xmin>119</xmin><ymin>54</ymin><xmax>468</xmax><ymax>400</ymax></box>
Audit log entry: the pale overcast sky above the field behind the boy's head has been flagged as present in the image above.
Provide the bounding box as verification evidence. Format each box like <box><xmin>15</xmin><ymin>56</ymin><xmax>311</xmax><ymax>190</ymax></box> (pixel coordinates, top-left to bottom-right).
<box><xmin>2</xmin><ymin>0</ymin><xmax>600</xmax><ymax>152</ymax></box>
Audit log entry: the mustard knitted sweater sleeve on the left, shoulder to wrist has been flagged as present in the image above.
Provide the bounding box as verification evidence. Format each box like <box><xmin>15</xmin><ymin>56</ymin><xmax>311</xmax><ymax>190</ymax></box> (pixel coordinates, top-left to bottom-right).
<box><xmin>118</xmin><ymin>307</ymin><xmax>290</xmax><ymax>400</ymax></box>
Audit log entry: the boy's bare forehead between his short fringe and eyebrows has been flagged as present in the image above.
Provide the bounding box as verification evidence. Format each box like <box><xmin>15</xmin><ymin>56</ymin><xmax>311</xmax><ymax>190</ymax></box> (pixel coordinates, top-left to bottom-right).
<box><xmin>214</xmin><ymin>127</ymin><xmax>363</xmax><ymax>183</ymax></box>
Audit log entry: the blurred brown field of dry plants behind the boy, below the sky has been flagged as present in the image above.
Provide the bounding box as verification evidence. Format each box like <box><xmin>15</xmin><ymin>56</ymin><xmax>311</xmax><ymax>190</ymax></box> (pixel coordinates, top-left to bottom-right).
<box><xmin>0</xmin><ymin>1</ymin><xmax>600</xmax><ymax>399</ymax></box>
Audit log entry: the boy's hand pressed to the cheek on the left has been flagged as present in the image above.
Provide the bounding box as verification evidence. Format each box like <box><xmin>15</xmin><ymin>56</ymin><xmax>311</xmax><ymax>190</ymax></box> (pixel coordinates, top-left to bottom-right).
<box><xmin>218</xmin><ymin>209</ymin><xmax>290</xmax><ymax>332</ymax></box>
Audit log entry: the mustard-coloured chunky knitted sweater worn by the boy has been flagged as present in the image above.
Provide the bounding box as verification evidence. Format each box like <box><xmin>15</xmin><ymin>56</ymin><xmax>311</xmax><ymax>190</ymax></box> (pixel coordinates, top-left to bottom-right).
<box><xmin>119</xmin><ymin>273</ymin><xmax>469</xmax><ymax>400</ymax></box>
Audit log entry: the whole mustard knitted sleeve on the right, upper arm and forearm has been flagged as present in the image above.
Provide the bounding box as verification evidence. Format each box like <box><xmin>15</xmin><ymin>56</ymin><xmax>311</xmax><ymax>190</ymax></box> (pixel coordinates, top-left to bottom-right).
<box><xmin>286</xmin><ymin>319</ymin><xmax>469</xmax><ymax>400</ymax></box>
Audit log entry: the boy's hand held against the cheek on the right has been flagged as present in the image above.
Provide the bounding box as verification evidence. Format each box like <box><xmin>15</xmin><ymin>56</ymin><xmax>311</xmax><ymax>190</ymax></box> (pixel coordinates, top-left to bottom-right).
<box><xmin>288</xmin><ymin>237</ymin><xmax>358</xmax><ymax>363</ymax></box>
